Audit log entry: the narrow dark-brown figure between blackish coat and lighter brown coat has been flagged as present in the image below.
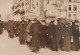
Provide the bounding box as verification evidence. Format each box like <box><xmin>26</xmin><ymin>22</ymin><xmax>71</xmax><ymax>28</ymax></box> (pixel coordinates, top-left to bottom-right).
<box><xmin>54</xmin><ymin>20</ymin><xmax>62</xmax><ymax>50</ymax></box>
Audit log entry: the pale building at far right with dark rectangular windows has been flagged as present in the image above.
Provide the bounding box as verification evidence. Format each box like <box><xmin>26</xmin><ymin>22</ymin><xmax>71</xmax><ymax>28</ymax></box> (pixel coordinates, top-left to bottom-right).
<box><xmin>67</xmin><ymin>0</ymin><xmax>80</xmax><ymax>20</ymax></box>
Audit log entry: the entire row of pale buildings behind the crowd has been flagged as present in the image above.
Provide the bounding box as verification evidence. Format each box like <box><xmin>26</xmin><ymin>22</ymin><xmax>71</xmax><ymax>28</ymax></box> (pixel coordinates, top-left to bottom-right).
<box><xmin>13</xmin><ymin>0</ymin><xmax>80</xmax><ymax>20</ymax></box>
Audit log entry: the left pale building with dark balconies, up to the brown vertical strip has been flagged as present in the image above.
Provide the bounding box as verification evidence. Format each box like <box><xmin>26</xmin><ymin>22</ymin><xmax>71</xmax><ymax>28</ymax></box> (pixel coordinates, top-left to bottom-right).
<box><xmin>12</xmin><ymin>0</ymin><xmax>44</xmax><ymax>20</ymax></box>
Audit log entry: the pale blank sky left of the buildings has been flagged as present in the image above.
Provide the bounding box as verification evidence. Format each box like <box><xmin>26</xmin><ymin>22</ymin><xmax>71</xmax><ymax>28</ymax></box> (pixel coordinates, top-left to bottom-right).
<box><xmin>0</xmin><ymin>0</ymin><xmax>13</xmax><ymax>20</ymax></box>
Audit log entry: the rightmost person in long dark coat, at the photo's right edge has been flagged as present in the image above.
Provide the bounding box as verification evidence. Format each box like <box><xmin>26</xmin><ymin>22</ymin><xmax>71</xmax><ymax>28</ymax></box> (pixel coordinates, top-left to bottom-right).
<box><xmin>71</xmin><ymin>20</ymin><xmax>79</xmax><ymax>51</ymax></box>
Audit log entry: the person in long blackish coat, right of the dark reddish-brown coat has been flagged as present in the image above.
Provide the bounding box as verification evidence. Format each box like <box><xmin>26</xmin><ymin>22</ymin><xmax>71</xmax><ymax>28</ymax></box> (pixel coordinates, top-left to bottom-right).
<box><xmin>48</xmin><ymin>21</ymin><xmax>57</xmax><ymax>51</ymax></box>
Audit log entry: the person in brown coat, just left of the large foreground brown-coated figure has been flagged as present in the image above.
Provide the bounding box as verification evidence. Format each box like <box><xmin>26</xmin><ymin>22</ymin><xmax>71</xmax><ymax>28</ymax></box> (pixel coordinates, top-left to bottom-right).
<box><xmin>17</xmin><ymin>20</ymin><xmax>27</xmax><ymax>44</ymax></box>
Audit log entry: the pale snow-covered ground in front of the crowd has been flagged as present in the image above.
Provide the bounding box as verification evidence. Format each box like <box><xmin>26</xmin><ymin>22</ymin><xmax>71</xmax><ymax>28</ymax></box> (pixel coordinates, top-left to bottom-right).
<box><xmin>0</xmin><ymin>31</ymin><xmax>80</xmax><ymax>55</ymax></box>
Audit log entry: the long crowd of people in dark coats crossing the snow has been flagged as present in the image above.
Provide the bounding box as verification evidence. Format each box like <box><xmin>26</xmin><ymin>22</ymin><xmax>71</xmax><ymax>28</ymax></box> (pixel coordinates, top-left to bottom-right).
<box><xmin>0</xmin><ymin>19</ymin><xmax>80</xmax><ymax>52</ymax></box>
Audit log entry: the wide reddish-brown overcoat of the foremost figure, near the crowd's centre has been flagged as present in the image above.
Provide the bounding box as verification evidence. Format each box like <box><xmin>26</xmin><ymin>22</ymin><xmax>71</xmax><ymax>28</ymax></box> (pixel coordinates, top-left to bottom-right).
<box><xmin>30</xmin><ymin>23</ymin><xmax>40</xmax><ymax>48</ymax></box>
